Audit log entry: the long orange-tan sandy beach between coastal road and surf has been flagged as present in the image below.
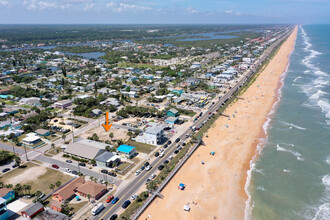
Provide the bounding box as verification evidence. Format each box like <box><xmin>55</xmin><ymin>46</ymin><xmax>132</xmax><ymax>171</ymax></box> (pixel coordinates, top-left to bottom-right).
<box><xmin>139</xmin><ymin>28</ymin><xmax>297</xmax><ymax>220</ymax></box>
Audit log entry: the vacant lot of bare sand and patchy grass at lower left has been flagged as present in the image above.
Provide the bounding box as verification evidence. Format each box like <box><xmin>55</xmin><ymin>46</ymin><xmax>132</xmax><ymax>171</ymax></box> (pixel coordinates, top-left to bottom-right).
<box><xmin>1</xmin><ymin>163</ymin><xmax>72</xmax><ymax>194</ymax></box>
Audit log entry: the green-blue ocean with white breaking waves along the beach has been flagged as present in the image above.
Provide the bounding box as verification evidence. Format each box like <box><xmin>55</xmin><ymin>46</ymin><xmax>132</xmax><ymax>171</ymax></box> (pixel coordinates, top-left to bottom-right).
<box><xmin>246</xmin><ymin>25</ymin><xmax>330</xmax><ymax>220</ymax></box>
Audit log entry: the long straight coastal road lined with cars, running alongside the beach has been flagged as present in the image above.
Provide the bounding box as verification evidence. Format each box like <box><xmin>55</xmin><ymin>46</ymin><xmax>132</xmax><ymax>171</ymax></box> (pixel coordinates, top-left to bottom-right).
<box><xmin>96</xmin><ymin>27</ymin><xmax>292</xmax><ymax>220</ymax></box>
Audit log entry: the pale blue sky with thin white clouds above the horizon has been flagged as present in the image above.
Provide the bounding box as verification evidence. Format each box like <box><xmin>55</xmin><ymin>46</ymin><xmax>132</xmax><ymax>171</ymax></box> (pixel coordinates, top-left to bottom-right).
<box><xmin>0</xmin><ymin>0</ymin><xmax>330</xmax><ymax>24</ymax></box>
